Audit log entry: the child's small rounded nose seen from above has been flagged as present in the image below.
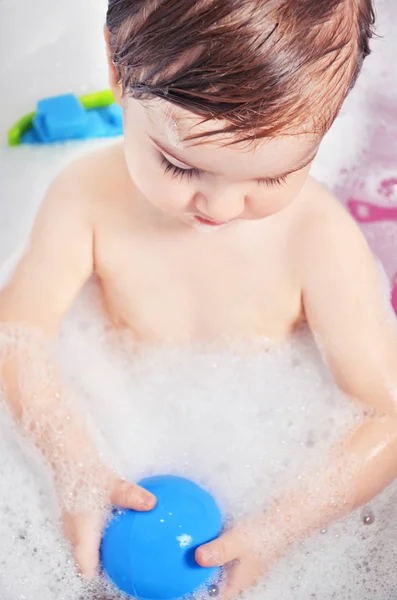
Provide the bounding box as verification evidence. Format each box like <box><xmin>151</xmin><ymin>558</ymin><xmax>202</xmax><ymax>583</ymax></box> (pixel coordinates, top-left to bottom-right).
<box><xmin>194</xmin><ymin>186</ymin><xmax>246</xmax><ymax>223</ymax></box>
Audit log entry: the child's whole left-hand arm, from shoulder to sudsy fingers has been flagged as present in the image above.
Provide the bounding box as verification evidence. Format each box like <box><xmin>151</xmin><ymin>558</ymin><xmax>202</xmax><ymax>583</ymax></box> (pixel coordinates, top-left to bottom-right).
<box><xmin>0</xmin><ymin>160</ymin><xmax>154</xmax><ymax>575</ymax></box>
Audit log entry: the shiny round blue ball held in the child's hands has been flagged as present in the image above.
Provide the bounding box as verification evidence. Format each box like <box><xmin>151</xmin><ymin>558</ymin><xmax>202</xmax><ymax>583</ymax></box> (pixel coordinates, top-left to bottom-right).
<box><xmin>101</xmin><ymin>475</ymin><xmax>222</xmax><ymax>600</ymax></box>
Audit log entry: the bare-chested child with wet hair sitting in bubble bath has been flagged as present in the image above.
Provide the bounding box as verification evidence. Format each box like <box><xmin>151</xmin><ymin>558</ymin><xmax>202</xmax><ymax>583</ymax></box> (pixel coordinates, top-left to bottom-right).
<box><xmin>0</xmin><ymin>0</ymin><xmax>397</xmax><ymax>600</ymax></box>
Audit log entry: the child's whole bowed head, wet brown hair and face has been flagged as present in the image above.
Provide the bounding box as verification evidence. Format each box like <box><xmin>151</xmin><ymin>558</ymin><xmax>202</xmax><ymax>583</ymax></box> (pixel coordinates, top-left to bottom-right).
<box><xmin>103</xmin><ymin>0</ymin><xmax>374</xmax><ymax>230</ymax></box>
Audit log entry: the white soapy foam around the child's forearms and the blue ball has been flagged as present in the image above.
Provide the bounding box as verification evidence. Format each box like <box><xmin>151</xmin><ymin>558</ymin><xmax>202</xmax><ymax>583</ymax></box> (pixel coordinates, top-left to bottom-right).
<box><xmin>0</xmin><ymin>281</ymin><xmax>397</xmax><ymax>600</ymax></box>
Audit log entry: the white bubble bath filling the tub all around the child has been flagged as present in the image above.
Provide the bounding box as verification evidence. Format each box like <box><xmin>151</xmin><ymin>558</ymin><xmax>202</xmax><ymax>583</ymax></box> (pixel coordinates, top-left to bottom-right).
<box><xmin>0</xmin><ymin>0</ymin><xmax>397</xmax><ymax>600</ymax></box>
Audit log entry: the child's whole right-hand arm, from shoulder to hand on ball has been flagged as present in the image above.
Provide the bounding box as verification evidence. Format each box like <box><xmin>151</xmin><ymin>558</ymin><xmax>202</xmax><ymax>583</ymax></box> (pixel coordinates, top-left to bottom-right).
<box><xmin>198</xmin><ymin>207</ymin><xmax>397</xmax><ymax>599</ymax></box>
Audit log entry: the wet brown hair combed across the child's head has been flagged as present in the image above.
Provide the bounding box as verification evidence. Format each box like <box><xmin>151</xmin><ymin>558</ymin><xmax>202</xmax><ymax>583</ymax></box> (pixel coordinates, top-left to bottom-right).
<box><xmin>107</xmin><ymin>0</ymin><xmax>375</xmax><ymax>140</ymax></box>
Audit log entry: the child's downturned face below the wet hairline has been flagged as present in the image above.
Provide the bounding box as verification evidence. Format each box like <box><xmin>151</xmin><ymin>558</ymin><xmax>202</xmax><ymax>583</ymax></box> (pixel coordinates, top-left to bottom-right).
<box><xmin>124</xmin><ymin>99</ymin><xmax>319</xmax><ymax>231</ymax></box>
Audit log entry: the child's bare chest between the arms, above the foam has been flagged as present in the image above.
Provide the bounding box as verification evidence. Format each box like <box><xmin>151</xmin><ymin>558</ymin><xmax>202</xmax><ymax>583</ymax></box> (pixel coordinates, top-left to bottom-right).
<box><xmin>96</xmin><ymin>220</ymin><xmax>301</xmax><ymax>342</ymax></box>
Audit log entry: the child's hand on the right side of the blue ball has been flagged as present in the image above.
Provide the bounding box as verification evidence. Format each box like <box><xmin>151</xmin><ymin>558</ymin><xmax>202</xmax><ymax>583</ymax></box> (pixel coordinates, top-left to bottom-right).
<box><xmin>196</xmin><ymin>519</ymin><xmax>281</xmax><ymax>600</ymax></box>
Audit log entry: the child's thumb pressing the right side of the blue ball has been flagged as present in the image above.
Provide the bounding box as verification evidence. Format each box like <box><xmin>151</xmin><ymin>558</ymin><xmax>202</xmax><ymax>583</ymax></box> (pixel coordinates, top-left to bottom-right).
<box><xmin>196</xmin><ymin>529</ymin><xmax>246</xmax><ymax>567</ymax></box>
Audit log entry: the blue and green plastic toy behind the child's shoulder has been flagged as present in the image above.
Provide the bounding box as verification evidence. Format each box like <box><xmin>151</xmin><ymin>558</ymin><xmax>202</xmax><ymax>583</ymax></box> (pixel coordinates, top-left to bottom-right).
<box><xmin>8</xmin><ymin>90</ymin><xmax>123</xmax><ymax>146</ymax></box>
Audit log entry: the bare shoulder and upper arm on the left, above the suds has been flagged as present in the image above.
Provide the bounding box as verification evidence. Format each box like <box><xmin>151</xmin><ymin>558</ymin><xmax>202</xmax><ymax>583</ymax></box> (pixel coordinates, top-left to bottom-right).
<box><xmin>0</xmin><ymin>148</ymin><xmax>130</xmax><ymax>336</ymax></box>
